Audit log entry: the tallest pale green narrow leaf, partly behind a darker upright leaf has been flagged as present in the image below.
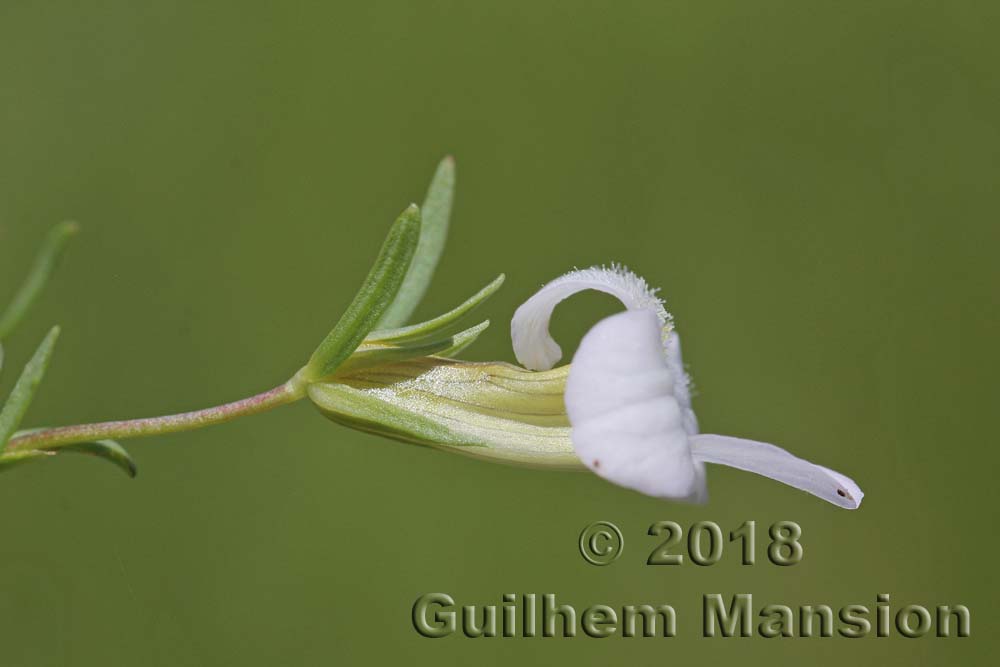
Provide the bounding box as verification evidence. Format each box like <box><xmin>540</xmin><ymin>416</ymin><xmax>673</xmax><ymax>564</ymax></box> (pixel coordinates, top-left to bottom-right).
<box><xmin>379</xmin><ymin>156</ymin><xmax>455</xmax><ymax>328</ymax></box>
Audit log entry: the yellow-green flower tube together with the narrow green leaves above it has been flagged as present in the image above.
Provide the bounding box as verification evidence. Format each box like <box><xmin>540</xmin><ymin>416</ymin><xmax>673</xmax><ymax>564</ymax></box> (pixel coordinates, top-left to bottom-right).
<box><xmin>299</xmin><ymin>159</ymin><xmax>580</xmax><ymax>469</ymax></box>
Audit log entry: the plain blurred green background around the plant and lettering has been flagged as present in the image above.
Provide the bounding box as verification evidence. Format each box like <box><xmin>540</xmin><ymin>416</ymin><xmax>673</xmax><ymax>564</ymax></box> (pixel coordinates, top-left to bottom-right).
<box><xmin>0</xmin><ymin>0</ymin><xmax>1000</xmax><ymax>666</ymax></box>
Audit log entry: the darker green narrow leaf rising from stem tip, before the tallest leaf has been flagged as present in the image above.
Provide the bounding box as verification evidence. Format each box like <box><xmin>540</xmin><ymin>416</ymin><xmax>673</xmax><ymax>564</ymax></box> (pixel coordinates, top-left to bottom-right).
<box><xmin>305</xmin><ymin>204</ymin><xmax>420</xmax><ymax>380</ymax></box>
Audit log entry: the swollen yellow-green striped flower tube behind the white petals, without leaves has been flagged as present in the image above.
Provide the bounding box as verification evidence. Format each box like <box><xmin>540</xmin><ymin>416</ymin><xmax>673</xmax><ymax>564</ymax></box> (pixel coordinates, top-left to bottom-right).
<box><xmin>308</xmin><ymin>357</ymin><xmax>581</xmax><ymax>469</ymax></box>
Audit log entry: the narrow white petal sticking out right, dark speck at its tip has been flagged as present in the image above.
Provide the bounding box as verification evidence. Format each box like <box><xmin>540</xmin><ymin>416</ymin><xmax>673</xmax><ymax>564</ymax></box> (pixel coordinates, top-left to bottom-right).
<box><xmin>691</xmin><ymin>434</ymin><xmax>865</xmax><ymax>510</ymax></box>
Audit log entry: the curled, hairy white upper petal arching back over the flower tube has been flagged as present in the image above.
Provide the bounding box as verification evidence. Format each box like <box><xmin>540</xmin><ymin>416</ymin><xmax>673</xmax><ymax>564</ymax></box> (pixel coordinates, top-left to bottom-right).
<box><xmin>510</xmin><ymin>265</ymin><xmax>672</xmax><ymax>371</ymax></box>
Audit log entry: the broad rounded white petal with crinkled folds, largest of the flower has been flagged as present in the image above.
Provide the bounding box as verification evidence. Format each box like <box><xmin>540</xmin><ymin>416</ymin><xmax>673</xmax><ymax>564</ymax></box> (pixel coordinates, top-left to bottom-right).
<box><xmin>565</xmin><ymin>310</ymin><xmax>706</xmax><ymax>501</ymax></box>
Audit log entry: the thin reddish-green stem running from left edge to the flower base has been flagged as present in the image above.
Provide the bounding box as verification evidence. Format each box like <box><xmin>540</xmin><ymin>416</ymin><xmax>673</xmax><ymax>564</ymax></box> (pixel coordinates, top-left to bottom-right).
<box><xmin>6</xmin><ymin>375</ymin><xmax>305</xmax><ymax>452</ymax></box>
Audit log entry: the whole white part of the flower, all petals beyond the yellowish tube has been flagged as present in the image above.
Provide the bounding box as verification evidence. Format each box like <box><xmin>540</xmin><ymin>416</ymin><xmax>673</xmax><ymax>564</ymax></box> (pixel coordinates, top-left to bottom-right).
<box><xmin>511</xmin><ymin>267</ymin><xmax>864</xmax><ymax>509</ymax></box>
